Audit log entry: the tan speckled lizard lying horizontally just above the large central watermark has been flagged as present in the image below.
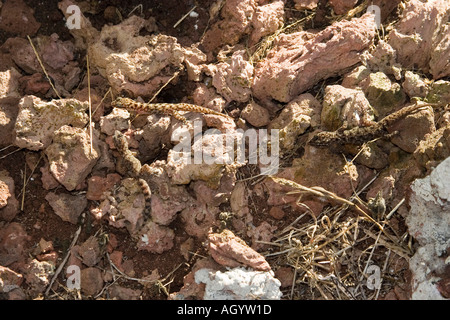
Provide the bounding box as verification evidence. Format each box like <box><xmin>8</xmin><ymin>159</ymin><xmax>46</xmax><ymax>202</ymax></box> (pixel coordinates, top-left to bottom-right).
<box><xmin>111</xmin><ymin>98</ymin><xmax>230</xmax><ymax>123</ymax></box>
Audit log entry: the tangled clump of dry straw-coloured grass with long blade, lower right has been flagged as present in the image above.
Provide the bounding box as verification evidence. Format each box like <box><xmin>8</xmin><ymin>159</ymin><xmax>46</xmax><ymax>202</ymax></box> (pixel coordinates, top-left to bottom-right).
<box><xmin>264</xmin><ymin>177</ymin><xmax>410</xmax><ymax>299</ymax></box>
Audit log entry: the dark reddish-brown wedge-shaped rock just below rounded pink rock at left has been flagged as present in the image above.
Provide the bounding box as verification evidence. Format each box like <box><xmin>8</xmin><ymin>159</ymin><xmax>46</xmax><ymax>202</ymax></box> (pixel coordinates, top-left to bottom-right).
<box><xmin>45</xmin><ymin>192</ymin><xmax>87</xmax><ymax>224</ymax></box>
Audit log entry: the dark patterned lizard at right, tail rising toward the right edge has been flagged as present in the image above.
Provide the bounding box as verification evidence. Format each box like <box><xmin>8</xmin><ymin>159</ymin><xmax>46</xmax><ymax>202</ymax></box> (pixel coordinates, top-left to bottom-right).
<box><xmin>309</xmin><ymin>103</ymin><xmax>442</xmax><ymax>146</ymax></box>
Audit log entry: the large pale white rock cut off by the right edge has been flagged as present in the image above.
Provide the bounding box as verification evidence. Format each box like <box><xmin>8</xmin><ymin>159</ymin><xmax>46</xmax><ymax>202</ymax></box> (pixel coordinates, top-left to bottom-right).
<box><xmin>406</xmin><ymin>158</ymin><xmax>450</xmax><ymax>299</ymax></box>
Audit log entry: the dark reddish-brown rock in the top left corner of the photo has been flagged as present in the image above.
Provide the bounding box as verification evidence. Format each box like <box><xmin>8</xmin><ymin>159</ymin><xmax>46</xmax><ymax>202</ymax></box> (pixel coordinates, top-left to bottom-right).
<box><xmin>0</xmin><ymin>0</ymin><xmax>41</xmax><ymax>37</ymax></box>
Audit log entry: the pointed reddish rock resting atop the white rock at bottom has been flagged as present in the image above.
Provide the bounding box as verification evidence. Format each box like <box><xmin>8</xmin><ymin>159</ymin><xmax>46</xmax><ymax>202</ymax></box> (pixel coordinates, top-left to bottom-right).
<box><xmin>208</xmin><ymin>229</ymin><xmax>271</xmax><ymax>271</ymax></box>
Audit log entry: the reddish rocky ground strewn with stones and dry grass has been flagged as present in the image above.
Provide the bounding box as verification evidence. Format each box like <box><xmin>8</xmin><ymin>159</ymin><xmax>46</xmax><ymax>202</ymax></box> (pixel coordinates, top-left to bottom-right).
<box><xmin>0</xmin><ymin>0</ymin><xmax>450</xmax><ymax>300</ymax></box>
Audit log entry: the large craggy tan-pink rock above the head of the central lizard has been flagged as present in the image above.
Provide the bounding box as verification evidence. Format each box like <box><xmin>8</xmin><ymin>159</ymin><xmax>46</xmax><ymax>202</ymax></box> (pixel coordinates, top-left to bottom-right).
<box><xmin>88</xmin><ymin>15</ymin><xmax>184</xmax><ymax>97</ymax></box>
